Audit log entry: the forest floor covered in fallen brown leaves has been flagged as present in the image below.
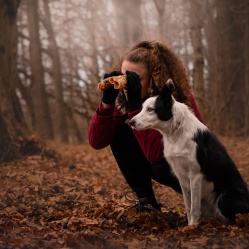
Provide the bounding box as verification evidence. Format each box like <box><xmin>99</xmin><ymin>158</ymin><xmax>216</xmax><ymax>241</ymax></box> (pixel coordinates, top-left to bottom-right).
<box><xmin>0</xmin><ymin>137</ymin><xmax>249</xmax><ymax>249</ymax></box>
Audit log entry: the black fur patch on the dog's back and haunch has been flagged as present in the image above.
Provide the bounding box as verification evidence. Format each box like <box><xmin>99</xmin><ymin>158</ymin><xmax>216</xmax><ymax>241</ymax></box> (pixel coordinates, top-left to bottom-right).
<box><xmin>193</xmin><ymin>131</ymin><xmax>249</xmax><ymax>220</ymax></box>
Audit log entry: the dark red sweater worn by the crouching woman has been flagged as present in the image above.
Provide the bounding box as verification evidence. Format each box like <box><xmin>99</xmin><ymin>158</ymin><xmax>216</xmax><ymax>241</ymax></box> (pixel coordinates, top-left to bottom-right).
<box><xmin>88</xmin><ymin>94</ymin><xmax>204</xmax><ymax>162</ymax></box>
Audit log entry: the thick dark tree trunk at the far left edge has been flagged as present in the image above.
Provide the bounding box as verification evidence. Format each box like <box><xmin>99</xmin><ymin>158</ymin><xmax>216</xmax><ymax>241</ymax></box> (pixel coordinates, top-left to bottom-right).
<box><xmin>0</xmin><ymin>0</ymin><xmax>27</xmax><ymax>163</ymax></box>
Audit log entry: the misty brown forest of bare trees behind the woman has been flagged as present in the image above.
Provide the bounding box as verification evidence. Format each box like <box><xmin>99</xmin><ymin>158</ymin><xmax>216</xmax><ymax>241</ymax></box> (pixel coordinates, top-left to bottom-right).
<box><xmin>0</xmin><ymin>0</ymin><xmax>249</xmax><ymax>162</ymax></box>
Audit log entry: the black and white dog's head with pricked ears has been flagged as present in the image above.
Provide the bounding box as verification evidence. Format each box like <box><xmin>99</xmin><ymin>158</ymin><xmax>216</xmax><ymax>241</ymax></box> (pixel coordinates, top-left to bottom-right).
<box><xmin>129</xmin><ymin>79</ymin><xmax>175</xmax><ymax>130</ymax></box>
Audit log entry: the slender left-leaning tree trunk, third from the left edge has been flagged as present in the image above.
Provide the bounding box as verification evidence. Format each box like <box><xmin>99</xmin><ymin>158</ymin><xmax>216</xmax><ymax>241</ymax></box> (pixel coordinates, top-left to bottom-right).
<box><xmin>43</xmin><ymin>0</ymin><xmax>68</xmax><ymax>143</ymax></box>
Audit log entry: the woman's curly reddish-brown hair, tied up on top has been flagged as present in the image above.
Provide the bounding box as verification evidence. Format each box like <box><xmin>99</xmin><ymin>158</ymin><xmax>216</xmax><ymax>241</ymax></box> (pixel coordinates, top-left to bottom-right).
<box><xmin>113</xmin><ymin>41</ymin><xmax>191</xmax><ymax>104</ymax></box>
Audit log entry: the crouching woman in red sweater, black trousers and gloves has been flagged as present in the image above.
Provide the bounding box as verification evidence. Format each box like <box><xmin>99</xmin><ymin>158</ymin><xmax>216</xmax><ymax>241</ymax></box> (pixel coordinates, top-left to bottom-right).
<box><xmin>88</xmin><ymin>41</ymin><xmax>203</xmax><ymax>211</ymax></box>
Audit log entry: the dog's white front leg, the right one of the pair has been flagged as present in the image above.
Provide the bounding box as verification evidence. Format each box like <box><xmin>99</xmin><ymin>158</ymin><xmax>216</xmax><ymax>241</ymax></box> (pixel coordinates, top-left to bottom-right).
<box><xmin>189</xmin><ymin>172</ymin><xmax>203</xmax><ymax>225</ymax></box>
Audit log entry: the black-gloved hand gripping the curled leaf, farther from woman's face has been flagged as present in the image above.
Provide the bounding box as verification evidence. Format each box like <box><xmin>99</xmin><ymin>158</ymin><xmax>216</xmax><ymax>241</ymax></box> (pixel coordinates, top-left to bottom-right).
<box><xmin>102</xmin><ymin>71</ymin><xmax>123</xmax><ymax>105</ymax></box>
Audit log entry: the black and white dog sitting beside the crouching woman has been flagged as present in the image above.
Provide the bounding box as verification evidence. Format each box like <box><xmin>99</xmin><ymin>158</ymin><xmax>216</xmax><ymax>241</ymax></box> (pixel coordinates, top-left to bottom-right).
<box><xmin>130</xmin><ymin>80</ymin><xmax>249</xmax><ymax>225</ymax></box>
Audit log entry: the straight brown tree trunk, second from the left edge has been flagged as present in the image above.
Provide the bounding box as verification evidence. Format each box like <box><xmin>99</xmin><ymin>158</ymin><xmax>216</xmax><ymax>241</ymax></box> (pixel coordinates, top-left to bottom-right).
<box><xmin>27</xmin><ymin>0</ymin><xmax>54</xmax><ymax>139</ymax></box>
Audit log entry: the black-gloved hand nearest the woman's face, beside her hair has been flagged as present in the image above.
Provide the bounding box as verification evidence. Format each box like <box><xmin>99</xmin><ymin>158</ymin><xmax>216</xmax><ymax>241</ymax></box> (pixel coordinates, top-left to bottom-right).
<box><xmin>126</xmin><ymin>71</ymin><xmax>142</xmax><ymax>111</ymax></box>
